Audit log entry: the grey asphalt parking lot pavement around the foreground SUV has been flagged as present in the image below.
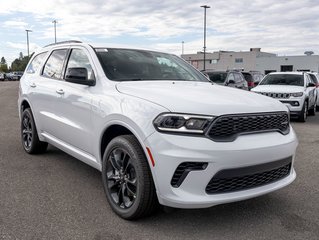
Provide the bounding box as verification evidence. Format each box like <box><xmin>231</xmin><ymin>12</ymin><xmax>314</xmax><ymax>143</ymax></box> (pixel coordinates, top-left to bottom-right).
<box><xmin>0</xmin><ymin>82</ymin><xmax>319</xmax><ymax>240</ymax></box>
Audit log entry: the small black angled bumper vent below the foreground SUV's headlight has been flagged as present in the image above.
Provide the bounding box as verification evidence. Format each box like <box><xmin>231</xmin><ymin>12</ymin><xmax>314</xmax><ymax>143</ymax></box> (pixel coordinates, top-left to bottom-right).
<box><xmin>171</xmin><ymin>162</ymin><xmax>208</xmax><ymax>188</ymax></box>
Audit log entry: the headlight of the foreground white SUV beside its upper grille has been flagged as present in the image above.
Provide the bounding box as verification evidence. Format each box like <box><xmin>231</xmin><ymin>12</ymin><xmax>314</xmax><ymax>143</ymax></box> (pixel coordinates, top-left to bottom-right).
<box><xmin>153</xmin><ymin>113</ymin><xmax>214</xmax><ymax>134</ymax></box>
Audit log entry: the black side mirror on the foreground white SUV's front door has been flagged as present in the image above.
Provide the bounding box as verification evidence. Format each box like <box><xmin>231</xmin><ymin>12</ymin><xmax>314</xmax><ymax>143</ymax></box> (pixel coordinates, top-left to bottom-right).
<box><xmin>65</xmin><ymin>68</ymin><xmax>95</xmax><ymax>86</ymax></box>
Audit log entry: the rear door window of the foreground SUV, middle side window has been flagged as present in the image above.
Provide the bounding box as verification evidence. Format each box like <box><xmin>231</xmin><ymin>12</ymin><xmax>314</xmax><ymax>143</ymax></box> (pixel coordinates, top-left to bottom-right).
<box><xmin>42</xmin><ymin>49</ymin><xmax>68</xmax><ymax>79</ymax></box>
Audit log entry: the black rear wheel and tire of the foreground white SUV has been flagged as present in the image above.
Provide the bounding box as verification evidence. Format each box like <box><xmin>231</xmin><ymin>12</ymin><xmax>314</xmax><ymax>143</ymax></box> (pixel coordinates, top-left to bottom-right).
<box><xmin>21</xmin><ymin>108</ymin><xmax>48</xmax><ymax>154</ymax></box>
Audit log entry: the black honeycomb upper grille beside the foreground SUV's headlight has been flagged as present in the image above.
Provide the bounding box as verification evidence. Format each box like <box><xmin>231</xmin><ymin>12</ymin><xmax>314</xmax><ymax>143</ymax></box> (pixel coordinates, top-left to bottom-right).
<box><xmin>207</xmin><ymin>112</ymin><xmax>289</xmax><ymax>142</ymax></box>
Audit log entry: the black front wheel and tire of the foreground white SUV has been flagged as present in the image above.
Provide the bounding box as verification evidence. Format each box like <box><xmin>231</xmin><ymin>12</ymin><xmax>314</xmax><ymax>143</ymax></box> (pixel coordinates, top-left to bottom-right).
<box><xmin>102</xmin><ymin>135</ymin><xmax>158</xmax><ymax>220</ymax></box>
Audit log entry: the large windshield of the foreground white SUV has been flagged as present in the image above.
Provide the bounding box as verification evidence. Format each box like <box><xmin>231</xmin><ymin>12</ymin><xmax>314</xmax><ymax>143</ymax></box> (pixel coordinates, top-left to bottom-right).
<box><xmin>95</xmin><ymin>48</ymin><xmax>209</xmax><ymax>82</ymax></box>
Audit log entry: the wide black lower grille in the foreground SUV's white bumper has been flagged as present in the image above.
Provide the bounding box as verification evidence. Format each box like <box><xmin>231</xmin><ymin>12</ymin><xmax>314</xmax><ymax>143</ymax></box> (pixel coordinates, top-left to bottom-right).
<box><xmin>206</xmin><ymin>158</ymin><xmax>291</xmax><ymax>194</ymax></box>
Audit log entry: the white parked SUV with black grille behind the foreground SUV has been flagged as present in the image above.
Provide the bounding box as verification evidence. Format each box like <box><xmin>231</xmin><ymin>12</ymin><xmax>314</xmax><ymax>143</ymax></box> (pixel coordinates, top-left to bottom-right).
<box><xmin>252</xmin><ymin>72</ymin><xmax>317</xmax><ymax>122</ymax></box>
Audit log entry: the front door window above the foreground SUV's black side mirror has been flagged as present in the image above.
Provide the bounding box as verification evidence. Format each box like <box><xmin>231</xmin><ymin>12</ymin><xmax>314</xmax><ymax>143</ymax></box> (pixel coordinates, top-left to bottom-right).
<box><xmin>67</xmin><ymin>49</ymin><xmax>94</xmax><ymax>80</ymax></box>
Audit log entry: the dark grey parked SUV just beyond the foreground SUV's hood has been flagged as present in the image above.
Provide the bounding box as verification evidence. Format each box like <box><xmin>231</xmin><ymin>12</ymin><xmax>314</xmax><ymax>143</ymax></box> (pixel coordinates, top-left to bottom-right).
<box><xmin>205</xmin><ymin>70</ymin><xmax>248</xmax><ymax>90</ymax></box>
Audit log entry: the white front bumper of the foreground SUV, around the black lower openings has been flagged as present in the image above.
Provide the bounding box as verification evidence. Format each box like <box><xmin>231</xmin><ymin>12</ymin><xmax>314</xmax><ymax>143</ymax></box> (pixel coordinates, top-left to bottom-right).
<box><xmin>145</xmin><ymin>128</ymin><xmax>298</xmax><ymax>208</ymax></box>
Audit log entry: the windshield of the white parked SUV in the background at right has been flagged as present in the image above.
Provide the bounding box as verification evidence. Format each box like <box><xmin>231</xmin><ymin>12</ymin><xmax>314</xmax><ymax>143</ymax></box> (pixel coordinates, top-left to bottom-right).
<box><xmin>259</xmin><ymin>74</ymin><xmax>304</xmax><ymax>86</ymax></box>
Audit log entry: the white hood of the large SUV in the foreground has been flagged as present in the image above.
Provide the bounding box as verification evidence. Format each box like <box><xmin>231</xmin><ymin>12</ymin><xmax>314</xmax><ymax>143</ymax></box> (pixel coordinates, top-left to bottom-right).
<box><xmin>116</xmin><ymin>81</ymin><xmax>287</xmax><ymax>115</ymax></box>
